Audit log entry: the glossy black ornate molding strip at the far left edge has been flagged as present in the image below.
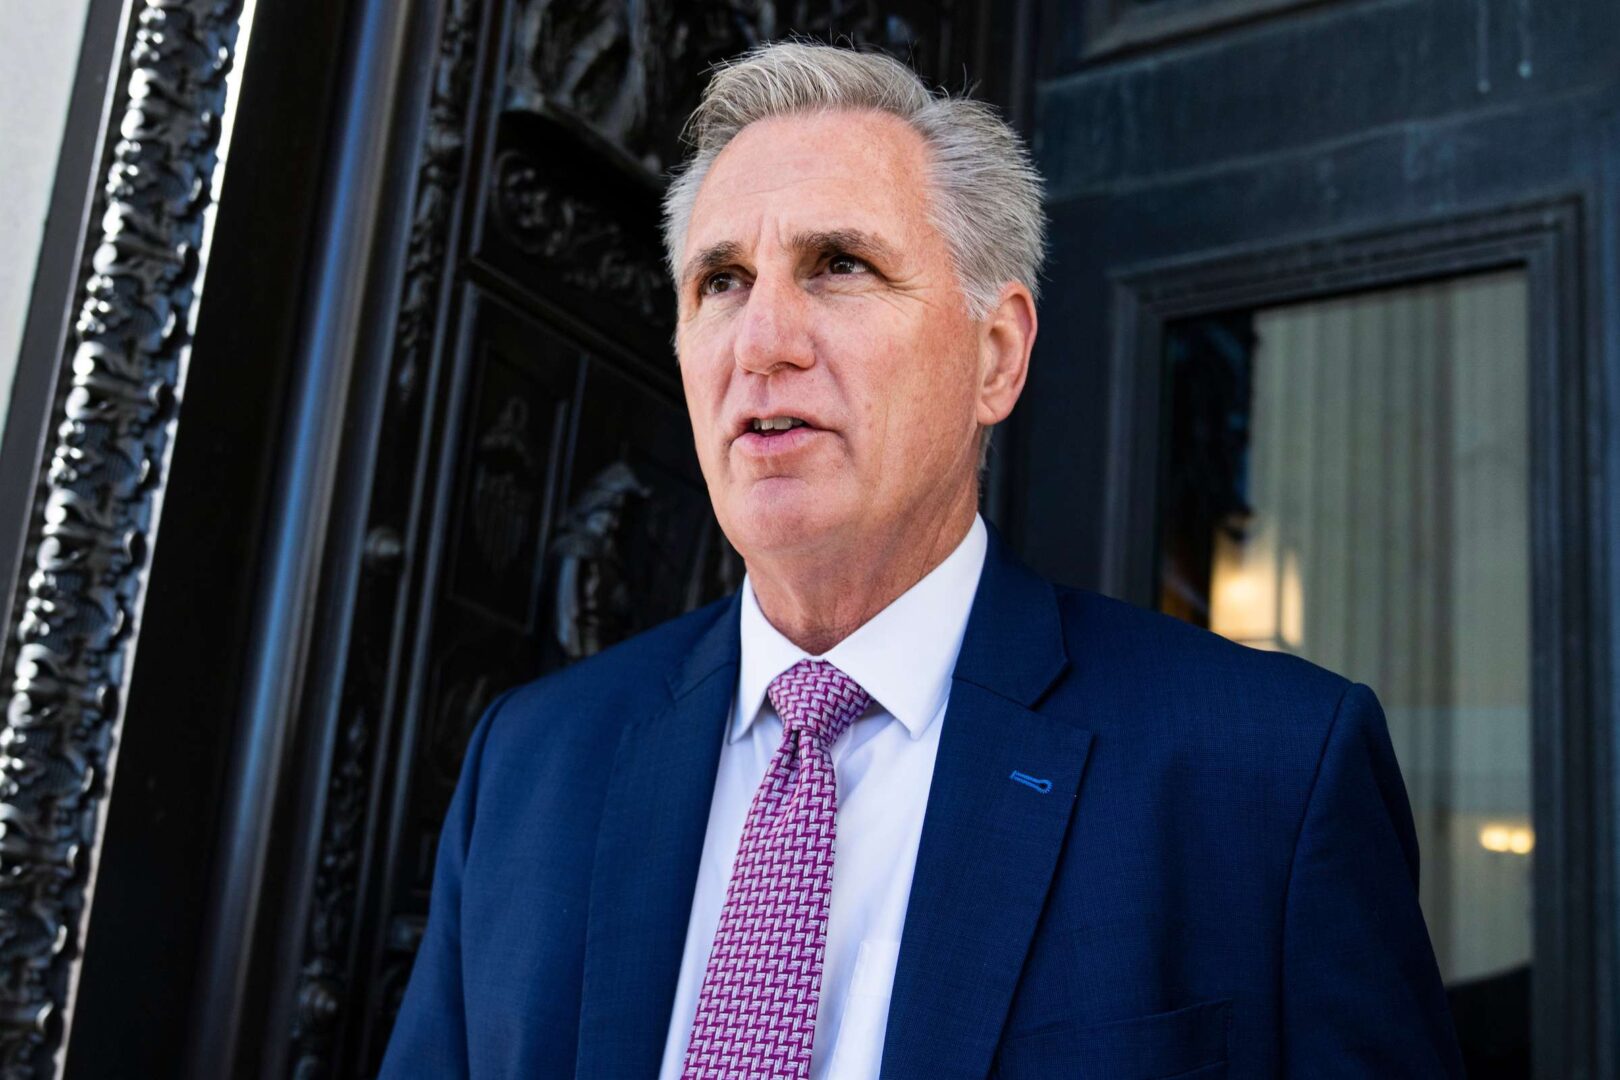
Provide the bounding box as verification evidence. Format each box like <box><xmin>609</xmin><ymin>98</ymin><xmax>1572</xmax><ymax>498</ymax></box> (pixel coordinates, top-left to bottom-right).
<box><xmin>0</xmin><ymin>0</ymin><xmax>241</xmax><ymax>1080</ymax></box>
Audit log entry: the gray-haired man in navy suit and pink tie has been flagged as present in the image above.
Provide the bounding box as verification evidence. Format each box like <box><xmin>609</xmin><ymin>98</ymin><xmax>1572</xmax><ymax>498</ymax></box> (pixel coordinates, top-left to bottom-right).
<box><xmin>372</xmin><ymin>44</ymin><xmax>1461</xmax><ymax>1080</ymax></box>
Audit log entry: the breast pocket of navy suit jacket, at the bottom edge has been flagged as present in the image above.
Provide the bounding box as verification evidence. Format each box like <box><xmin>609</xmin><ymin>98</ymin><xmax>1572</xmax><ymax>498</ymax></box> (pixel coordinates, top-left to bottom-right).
<box><xmin>993</xmin><ymin>999</ymin><xmax>1231</xmax><ymax>1080</ymax></box>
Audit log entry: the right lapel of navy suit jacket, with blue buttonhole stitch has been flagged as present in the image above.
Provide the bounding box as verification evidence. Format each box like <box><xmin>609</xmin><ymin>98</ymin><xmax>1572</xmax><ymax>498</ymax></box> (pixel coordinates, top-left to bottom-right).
<box><xmin>883</xmin><ymin>533</ymin><xmax>1090</xmax><ymax>1080</ymax></box>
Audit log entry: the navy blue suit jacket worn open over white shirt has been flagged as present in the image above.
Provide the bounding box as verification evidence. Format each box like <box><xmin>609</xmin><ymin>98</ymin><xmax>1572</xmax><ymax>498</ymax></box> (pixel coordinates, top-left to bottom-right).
<box><xmin>382</xmin><ymin>533</ymin><xmax>1461</xmax><ymax>1080</ymax></box>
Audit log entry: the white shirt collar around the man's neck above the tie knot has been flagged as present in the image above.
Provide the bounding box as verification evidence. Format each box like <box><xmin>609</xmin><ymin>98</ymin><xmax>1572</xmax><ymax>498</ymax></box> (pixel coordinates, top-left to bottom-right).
<box><xmin>727</xmin><ymin>513</ymin><xmax>988</xmax><ymax>742</ymax></box>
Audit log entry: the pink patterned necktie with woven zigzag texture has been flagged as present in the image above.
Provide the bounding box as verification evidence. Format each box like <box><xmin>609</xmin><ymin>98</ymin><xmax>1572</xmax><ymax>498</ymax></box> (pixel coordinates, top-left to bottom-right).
<box><xmin>680</xmin><ymin>661</ymin><xmax>870</xmax><ymax>1080</ymax></box>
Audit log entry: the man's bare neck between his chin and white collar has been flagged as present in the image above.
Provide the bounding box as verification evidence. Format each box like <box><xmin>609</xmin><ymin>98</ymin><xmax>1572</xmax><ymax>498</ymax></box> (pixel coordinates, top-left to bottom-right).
<box><xmin>747</xmin><ymin>499</ymin><xmax>977</xmax><ymax>656</ymax></box>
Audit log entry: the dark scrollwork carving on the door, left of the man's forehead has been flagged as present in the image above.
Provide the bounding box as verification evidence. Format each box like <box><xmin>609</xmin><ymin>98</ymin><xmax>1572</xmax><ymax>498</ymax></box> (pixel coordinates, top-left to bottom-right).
<box><xmin>494</xmin><ymin>151</ymin><xmax>674</xmax><ymax>319</ymax></box>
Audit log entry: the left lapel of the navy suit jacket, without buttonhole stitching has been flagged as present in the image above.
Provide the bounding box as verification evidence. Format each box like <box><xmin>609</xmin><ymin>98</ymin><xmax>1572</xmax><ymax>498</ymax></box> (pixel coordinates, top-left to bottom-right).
<box><xmin>575</xmin><ymin>599</ymin><xmax>739</xmax><ymax>1080</ymax></box>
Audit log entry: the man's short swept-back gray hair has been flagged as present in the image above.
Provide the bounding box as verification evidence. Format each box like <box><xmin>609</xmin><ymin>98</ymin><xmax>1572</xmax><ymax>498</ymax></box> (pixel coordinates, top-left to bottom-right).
<box><xmin>664</xmin><ymin>40</ymin><xmax>1047</xmax><ymax>319</ymax></box>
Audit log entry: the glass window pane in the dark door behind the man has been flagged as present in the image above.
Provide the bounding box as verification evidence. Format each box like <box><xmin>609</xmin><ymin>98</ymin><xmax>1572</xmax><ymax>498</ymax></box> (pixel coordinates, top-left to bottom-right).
<box><xmin>1160</xmin><ymin>270</ymin><xmax>1536</xmax><ymax>1075</ymax></box>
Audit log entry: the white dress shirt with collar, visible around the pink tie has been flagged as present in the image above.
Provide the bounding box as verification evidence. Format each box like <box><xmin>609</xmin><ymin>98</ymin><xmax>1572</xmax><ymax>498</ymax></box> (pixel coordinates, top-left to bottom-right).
<box><xmin>658</xmin><ymin>515</ymin><xmax>987</xmax><ymax>1080</ymax></box>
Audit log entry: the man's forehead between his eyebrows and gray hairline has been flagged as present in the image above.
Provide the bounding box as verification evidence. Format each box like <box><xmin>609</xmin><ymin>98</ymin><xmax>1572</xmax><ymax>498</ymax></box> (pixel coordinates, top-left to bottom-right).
<box><xmin>685</xmin><ymin>110</ymin><xmax>932</xmax><ymax>251</ymax></box>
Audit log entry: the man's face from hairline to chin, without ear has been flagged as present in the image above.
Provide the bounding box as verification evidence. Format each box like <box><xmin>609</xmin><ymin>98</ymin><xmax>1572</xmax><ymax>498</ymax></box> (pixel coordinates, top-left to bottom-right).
<box><xmin>676</xmin><ymin>112</ymin><xmax>978</xmax><ymax>559</ymax></box>
